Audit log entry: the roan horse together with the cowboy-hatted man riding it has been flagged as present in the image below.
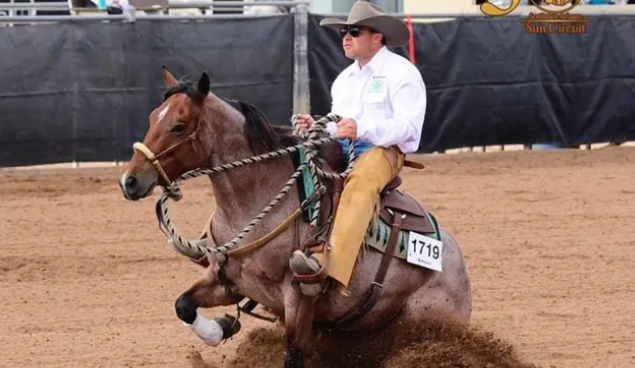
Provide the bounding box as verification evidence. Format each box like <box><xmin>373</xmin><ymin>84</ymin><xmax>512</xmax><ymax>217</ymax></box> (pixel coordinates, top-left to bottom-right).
<box><xmin>119</xmin><ymin>2</ymin><xmax>472</xmax><ymax>368</ymax></box>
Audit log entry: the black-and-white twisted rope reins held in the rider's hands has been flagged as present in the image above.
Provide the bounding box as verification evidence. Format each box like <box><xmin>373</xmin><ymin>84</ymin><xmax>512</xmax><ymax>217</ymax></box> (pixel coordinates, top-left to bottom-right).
<box><xmin>156</xmin><ymin>114</ymin><xmax>356</xmax><ymax>263</ymax></box>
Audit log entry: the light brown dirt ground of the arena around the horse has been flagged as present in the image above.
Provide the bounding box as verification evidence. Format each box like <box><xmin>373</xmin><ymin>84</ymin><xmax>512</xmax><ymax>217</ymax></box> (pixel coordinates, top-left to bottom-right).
<box><xmin>0</xmin><ymin>147</ymin><xmax>635</xmax><ymax>368</ymax></box>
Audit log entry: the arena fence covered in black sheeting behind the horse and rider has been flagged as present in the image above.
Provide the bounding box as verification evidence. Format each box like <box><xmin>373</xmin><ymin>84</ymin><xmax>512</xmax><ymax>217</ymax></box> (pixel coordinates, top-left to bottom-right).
<box><xmin>0</xmin><ymin>1</ymin><xmax>635</xmax><ymax>167</ymax></box>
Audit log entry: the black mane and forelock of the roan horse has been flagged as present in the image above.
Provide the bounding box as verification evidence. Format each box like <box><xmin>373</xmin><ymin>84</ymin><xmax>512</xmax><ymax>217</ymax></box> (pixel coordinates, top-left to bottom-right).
<box><xmin>163</xmin><ymin>80</ymin><xmax>299</xmax><ymax>155</ymax></box>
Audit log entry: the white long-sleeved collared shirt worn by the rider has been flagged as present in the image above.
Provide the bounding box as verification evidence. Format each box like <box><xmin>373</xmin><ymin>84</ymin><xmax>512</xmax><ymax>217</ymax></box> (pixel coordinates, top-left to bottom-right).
<box><xmin>327</xmin><ymin>46</ymin><xmax>427</xmax><ymax>153</ymax></box>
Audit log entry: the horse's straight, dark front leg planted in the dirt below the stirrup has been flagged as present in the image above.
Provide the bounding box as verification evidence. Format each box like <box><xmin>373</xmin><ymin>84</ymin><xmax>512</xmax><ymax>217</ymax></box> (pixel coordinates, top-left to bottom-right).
<box><xmin>284</xmin><ymin>286</ymin><xmax>317</xmax><ymax>368</ymax></box>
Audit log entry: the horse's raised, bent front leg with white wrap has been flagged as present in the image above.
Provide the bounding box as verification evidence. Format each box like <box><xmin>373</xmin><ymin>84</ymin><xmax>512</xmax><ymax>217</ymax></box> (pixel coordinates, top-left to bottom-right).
<box><xmin>175</xmin><ymin>277</ymin><xmax>244</xmax><ymax>346</ymax></box>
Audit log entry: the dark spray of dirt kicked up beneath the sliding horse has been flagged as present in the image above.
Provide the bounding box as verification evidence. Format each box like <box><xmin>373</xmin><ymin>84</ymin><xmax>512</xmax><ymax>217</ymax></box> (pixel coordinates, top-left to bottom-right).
<box><xmin>191</xmin><ymin>320</ymin><xmax>538</xmax><ymax>368</ymax></box>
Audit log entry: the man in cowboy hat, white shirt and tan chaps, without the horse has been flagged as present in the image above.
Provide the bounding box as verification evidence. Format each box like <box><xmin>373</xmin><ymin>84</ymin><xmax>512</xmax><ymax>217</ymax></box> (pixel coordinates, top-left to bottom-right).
<box><xmin>289</xmin><ymin>1</ymin><xmax>427</xmax><ymax>295</ymax></box>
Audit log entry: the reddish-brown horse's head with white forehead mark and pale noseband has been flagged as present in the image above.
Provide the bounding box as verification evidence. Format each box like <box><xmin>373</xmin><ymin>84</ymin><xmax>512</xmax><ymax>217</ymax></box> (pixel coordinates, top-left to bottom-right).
<box><xmin>119</xmin><ymin>67</ymin><xmax>217</xmax><ymax>200</ymax></box>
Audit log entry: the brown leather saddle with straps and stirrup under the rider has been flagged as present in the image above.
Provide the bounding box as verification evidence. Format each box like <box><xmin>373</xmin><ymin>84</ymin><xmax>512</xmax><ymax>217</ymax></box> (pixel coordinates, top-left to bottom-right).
<box><xmin>296</xmin><ymin>142</ymin><xmax>435</xmax><ymax>326</ymax></box>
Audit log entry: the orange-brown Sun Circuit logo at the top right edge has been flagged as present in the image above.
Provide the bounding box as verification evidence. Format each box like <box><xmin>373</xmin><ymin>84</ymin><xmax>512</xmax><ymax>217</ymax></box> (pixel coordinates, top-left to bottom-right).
<box><xmin>481</xmin><ymin>0</ymin><xmax>590</xmax><ymax>34</ymax></box>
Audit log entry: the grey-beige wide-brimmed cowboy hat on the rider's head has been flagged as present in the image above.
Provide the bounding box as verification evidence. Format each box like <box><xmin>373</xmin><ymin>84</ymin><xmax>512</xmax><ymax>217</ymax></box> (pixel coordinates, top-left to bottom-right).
<box><xmin>320</xmin><ymin>1</ymin><xmax>410</xmax><ymax>46</ymax></box>
